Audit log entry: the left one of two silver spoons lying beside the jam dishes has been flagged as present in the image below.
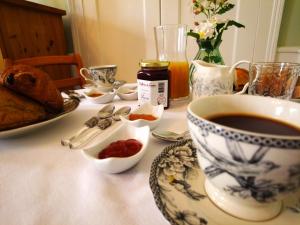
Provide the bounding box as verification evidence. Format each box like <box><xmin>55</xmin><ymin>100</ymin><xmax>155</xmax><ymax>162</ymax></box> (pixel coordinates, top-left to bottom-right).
<box><xmin>61</xmin><ymin>104</ymin><xmax>115</xmax><ymax>146</ymax></box>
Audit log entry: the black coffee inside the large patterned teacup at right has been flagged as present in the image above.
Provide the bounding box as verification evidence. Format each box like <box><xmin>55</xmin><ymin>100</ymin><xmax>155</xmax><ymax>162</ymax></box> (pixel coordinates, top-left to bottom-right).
<box><xmin>207</xmin><ymin>114</ymin><xmax>300</xmax><ymax>136</ymax></box>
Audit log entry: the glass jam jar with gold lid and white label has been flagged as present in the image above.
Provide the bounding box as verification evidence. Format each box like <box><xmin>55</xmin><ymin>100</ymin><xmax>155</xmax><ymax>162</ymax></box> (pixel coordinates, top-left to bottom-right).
<box><xmin>137</xmin><ymin>60</ymin><xmax>170</xmax><ymax>109</ymax></box>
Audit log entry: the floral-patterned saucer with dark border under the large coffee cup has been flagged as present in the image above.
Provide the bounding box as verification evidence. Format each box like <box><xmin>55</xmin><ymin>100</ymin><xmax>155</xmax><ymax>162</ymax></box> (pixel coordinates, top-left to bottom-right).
<box><xmin>149</xmin><ymin>139</ymin><xmax>300</xmax><ymax>225</ymax></box>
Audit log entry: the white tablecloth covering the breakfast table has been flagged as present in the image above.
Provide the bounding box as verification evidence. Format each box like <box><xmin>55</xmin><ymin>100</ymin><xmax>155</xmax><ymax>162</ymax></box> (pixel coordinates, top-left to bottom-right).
<box><xmin>0</xmin><ymin>98</ymin><xmax>187</xmax><ymax>225</ymax></box>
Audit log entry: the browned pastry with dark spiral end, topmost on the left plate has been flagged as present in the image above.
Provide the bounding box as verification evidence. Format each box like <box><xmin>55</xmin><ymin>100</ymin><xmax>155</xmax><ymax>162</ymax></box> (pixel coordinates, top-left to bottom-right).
<box><xmin>0</xmin><ymin>64</ymin><xmax>63</xmax><ymax>113</ymax></box>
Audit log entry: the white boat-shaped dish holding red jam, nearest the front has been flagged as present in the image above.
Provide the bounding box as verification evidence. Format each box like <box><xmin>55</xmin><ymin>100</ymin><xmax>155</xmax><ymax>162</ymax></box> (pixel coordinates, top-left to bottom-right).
<box><xmin>81</xmin><ymin>124</ymin><xmax>150</xmax><ymax>173</ymax></box>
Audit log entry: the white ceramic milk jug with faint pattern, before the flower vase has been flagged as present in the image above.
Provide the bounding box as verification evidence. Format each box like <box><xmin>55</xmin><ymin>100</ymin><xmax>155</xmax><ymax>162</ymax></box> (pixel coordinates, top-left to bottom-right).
<box><xmin>191</xmin><ymin>60</ymin><xmax>250</xmax><ymax>100</ymax></box>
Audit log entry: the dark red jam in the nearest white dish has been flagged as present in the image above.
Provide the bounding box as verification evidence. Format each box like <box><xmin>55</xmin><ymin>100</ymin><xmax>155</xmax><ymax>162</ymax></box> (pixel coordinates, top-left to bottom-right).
<box><xmin>98</xmin><ymin>139</ymin><xmax>143</xmax><ymax>159</ymax></box>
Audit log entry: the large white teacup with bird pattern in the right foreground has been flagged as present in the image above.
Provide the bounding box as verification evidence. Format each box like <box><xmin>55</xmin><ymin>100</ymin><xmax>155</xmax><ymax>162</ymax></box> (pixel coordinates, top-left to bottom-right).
<box><xmin>187</xmin><ymin>95</ymin><xmax>300</xmax><ymax>221</ymax></box>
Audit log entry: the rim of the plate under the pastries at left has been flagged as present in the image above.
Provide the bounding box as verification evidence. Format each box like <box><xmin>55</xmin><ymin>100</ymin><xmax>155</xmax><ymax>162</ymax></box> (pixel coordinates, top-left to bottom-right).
<box><xmin>0</xmin><ymin>98</ymin><xmax>79</xmax><ymax>138</ymax></box>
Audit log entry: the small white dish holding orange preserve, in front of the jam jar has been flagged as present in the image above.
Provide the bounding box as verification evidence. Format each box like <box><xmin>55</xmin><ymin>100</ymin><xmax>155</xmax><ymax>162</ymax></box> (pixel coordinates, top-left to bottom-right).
<box><xmin>121</xmin><ymin>102</ymin><xmax>164</xmax><ymax>130</ymax></box>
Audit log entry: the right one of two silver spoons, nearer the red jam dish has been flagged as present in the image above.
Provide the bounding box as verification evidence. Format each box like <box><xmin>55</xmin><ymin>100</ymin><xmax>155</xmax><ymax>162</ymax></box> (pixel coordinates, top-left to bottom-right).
<box><xmin>69</xmin><ymin>106</ymin><xmax>131</xmax><ymax>149</ymax></box>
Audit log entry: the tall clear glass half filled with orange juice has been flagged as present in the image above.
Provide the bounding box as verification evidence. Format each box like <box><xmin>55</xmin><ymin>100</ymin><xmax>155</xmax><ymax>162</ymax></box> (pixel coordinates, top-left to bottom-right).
<box><xmin>154</xmin><ymin>24</ymin><xmax>189</xmax><ymax>100</ymax></box>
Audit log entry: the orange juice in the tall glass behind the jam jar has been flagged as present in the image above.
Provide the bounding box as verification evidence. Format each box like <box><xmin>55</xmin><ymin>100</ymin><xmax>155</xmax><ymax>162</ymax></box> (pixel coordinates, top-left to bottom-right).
<box><xmin>169</xmin><ymin>61</ymin><xmax>189</xmax><ymax>99</ymax></box>
